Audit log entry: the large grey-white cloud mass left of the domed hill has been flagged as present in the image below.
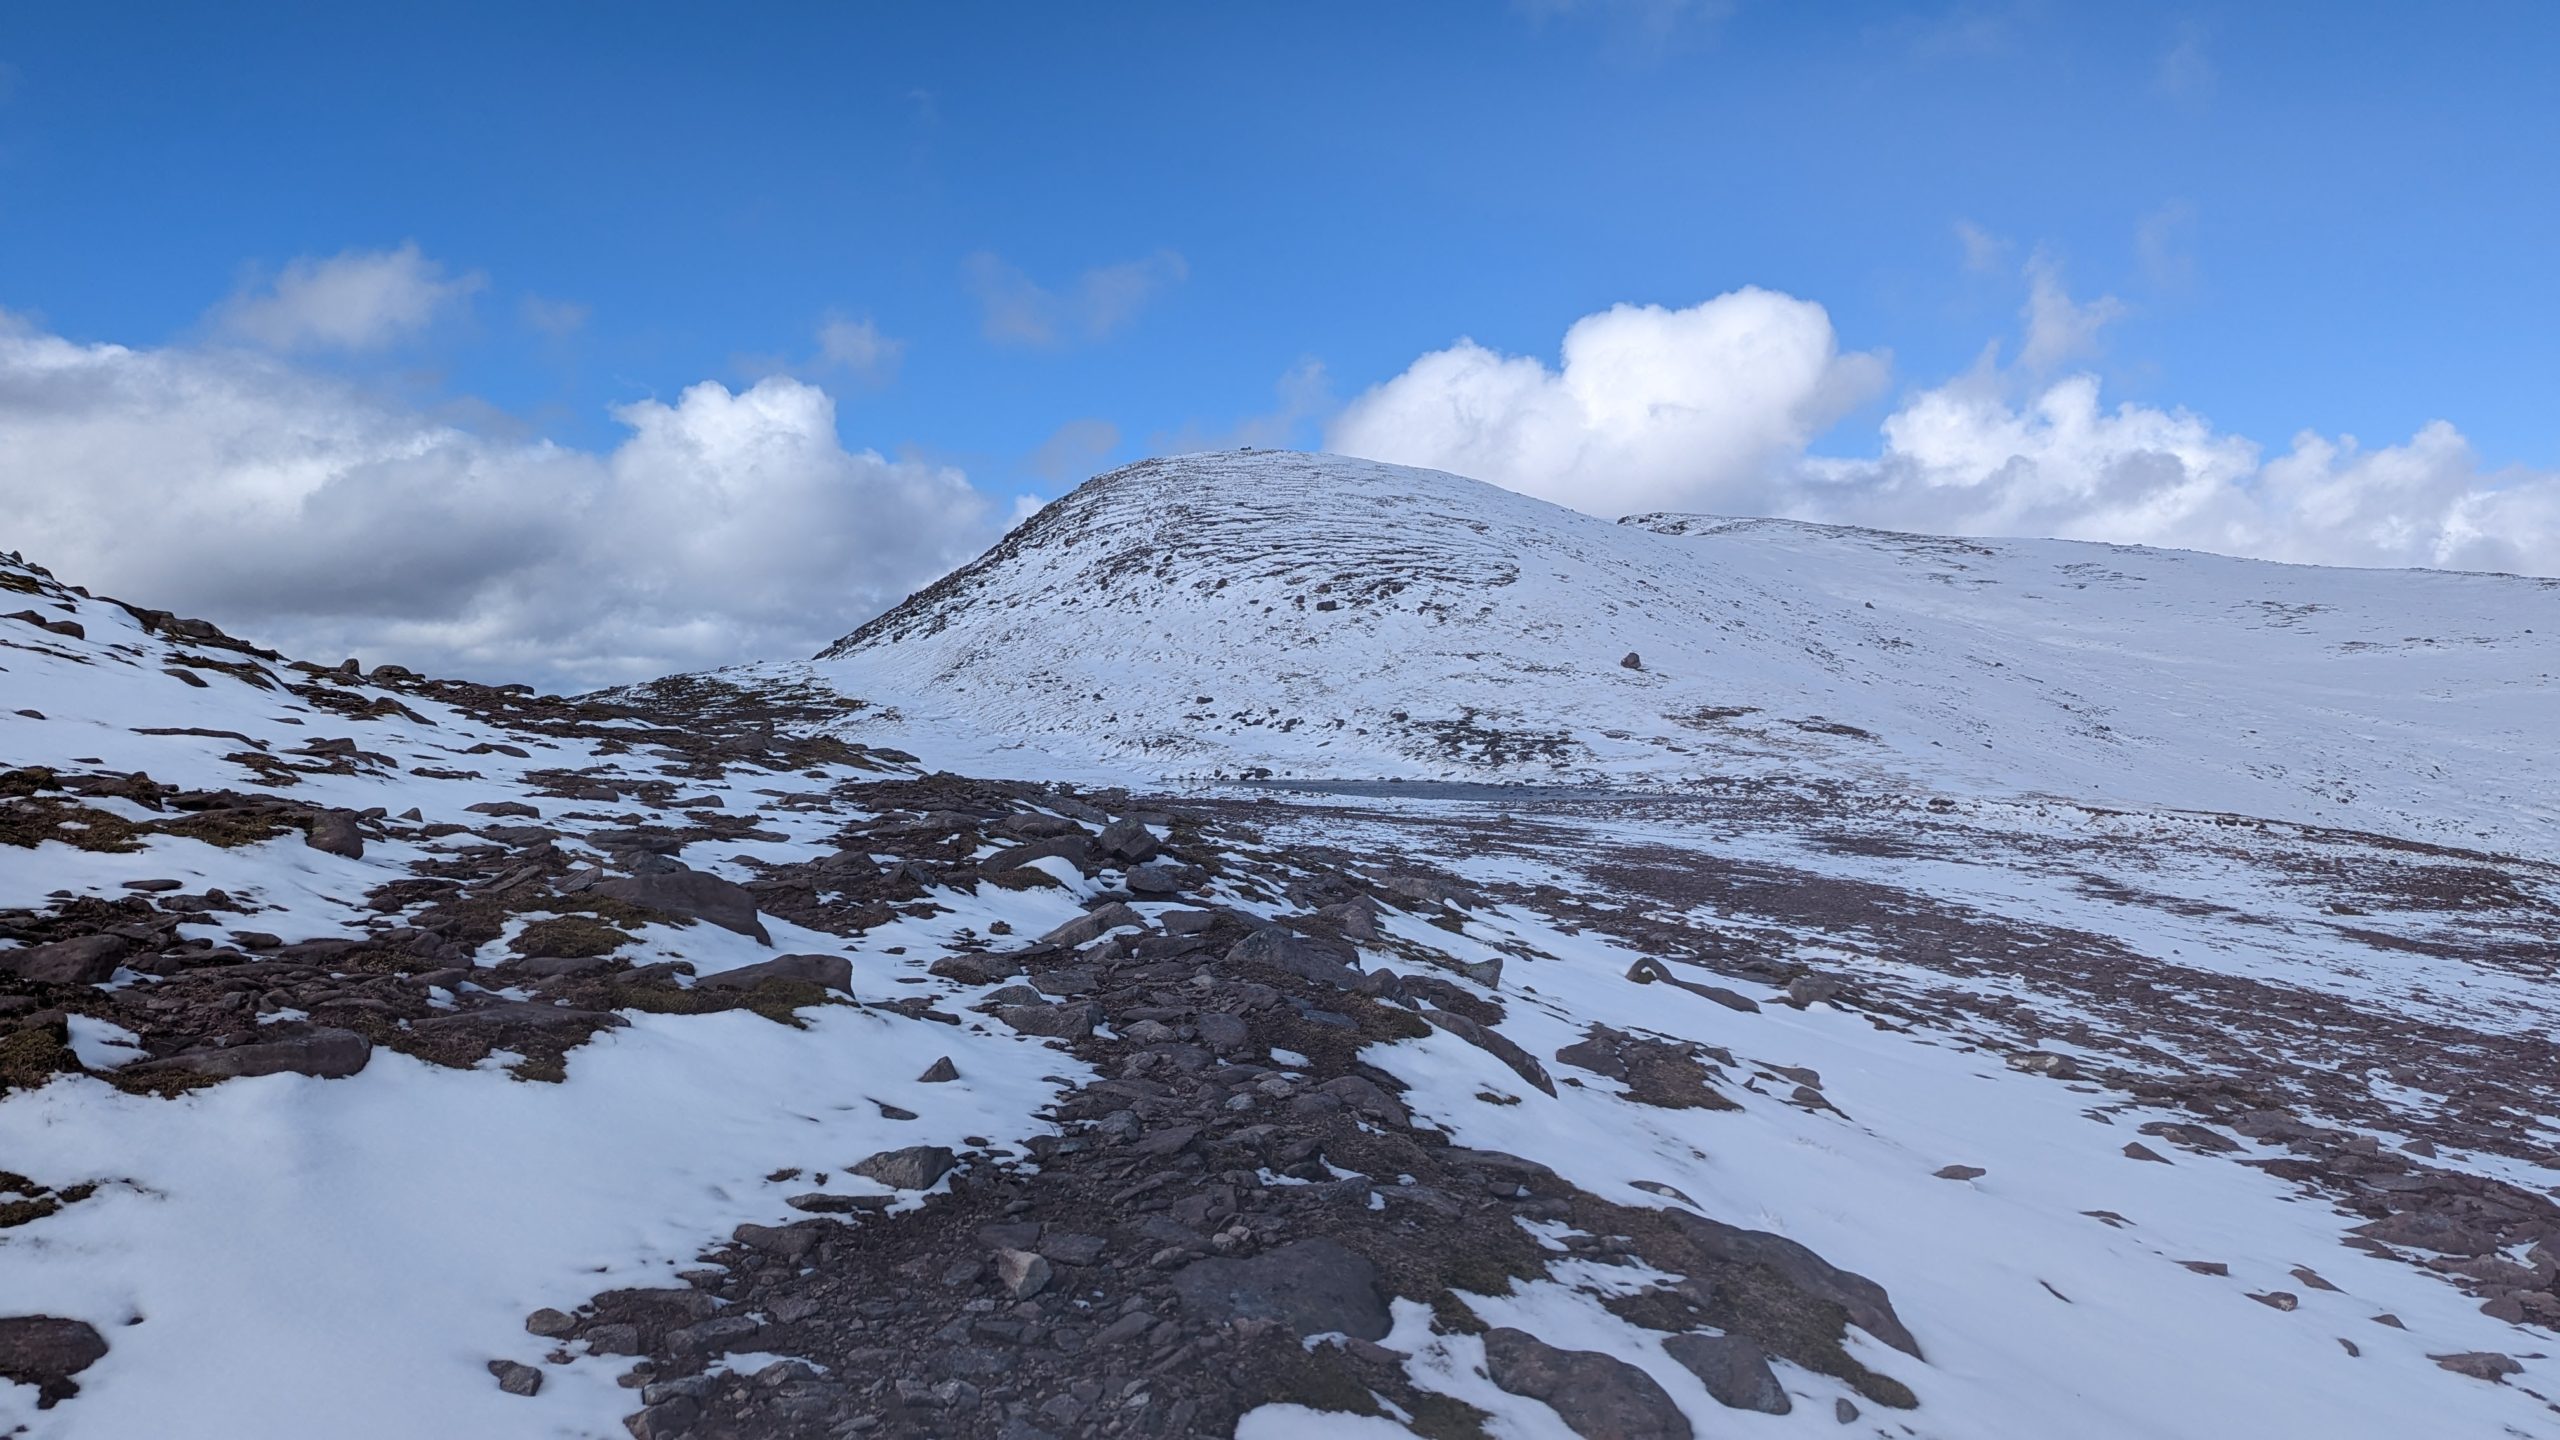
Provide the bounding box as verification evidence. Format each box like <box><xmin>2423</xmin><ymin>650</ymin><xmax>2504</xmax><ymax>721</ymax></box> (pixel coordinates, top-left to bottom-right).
<box><xmin>0</xmin><ymin>325</ymin><xmax>1004</xmax><ymax>687</ymax></box>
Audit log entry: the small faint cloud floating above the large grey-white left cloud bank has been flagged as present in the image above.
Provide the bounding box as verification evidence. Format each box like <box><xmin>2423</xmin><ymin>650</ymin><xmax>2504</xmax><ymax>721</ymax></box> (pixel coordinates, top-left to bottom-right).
<box><xmin>215</xmin><ymin>241</ymin><xmax>486</xmax><ymax>351</ymax></box>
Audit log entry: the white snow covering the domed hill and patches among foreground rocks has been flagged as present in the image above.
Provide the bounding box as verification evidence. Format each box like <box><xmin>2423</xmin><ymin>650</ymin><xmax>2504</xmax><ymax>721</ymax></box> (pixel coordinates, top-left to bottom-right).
<box><xmin>0</xmin><ymin>454</ymin><xmax>2560</xmax><ymax>1440</ymax></box>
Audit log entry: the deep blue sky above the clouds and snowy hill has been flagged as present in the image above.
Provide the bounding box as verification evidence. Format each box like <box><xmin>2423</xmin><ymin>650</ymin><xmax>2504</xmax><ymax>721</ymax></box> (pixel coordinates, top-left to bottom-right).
<box><xmin>0</xmin><ymin>0</ymin><xmax>2560</xmax><ymax>676</ymax></box>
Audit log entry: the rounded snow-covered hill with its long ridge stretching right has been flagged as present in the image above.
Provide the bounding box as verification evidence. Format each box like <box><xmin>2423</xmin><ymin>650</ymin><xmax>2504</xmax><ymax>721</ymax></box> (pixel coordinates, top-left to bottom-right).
<box><xmin>817</xmin><ymin>454</ymin><xmax>2560</xmax><ymax>853</ymax></box>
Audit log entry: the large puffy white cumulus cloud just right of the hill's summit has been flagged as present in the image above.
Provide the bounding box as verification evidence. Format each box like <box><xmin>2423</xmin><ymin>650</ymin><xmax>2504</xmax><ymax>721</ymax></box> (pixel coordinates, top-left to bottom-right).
<box><xmin>1326</xmin><ymin>287</ymin><xmax>1887</xmax><ymax>515</ymax></box>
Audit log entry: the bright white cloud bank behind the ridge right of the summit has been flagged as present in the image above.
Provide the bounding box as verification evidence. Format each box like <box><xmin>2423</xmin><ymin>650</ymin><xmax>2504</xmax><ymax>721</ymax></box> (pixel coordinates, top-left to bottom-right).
<box><xmin>1326</xmin><ymin>256</ymin><xmax>2560</xmax><ymax>574</ymax></box>
